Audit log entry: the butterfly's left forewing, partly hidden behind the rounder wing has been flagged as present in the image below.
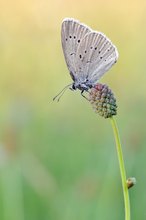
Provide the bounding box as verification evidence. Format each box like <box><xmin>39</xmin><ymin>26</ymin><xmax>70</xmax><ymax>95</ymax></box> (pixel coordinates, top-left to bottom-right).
<box><xmin>61</xmin><ymin>18</ymin><xmax>91</xmax><ymax>81</ymax></box>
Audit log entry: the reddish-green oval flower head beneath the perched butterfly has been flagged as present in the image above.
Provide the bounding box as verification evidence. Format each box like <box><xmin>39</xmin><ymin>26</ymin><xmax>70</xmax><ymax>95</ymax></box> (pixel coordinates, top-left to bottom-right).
<box><xmin>89</xmin><ymin>83</ymin><xmax>117</xmax><ymax>118</ymax></box>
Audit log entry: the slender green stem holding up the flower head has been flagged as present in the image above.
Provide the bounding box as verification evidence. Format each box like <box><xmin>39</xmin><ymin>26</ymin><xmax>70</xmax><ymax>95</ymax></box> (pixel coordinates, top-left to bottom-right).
<box><xmin>110</xmin><ymin>117</ymin><xmax>130</xmax><ymax>220</ymax></box>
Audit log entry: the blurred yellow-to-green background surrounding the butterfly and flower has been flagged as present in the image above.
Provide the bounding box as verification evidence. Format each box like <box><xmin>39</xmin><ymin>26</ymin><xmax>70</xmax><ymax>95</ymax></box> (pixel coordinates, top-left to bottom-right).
<box><xmin>0</xmin><ymin>0</ymin><xmax>146</xmax><ymax>220</ymax></box>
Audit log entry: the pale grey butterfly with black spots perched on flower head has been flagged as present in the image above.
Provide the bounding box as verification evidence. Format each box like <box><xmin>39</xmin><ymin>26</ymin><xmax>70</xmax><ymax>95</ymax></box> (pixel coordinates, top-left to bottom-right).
<box><xmin>54</xmin><ymin>18</ymin><xmax>118</xmax><ymax>99</ymax></box>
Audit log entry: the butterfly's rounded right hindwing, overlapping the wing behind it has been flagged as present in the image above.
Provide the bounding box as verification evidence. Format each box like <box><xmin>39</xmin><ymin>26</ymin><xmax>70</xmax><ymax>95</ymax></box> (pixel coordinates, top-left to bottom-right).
<box><xmin>75</xmin><ymin>31</ymin><xmax>118</xmax><ymax>85</ymax></box>
